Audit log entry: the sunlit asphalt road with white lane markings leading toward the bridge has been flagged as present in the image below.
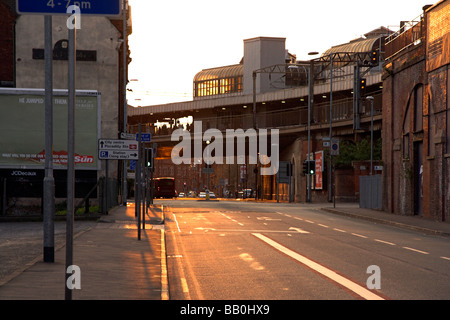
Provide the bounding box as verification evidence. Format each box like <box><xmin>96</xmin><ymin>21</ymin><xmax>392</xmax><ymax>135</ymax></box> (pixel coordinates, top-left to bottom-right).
<box><xmin>161</xmin><ymin>200</ymin><xmax>450</xmax><ymax>300</ymax></box>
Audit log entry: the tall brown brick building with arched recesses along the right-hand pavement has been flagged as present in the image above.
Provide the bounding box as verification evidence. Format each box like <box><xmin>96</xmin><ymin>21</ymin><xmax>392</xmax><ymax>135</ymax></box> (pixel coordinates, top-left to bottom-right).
<box><xmin>382</xmin><ymin>0</ymin><xmax>450</xmax><ymax>221</ymax></box>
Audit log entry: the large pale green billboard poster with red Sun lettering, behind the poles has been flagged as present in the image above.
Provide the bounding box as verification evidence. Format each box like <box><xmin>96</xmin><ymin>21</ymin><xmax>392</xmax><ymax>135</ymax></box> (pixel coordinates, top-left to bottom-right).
<box><xmin>0</xmin><ymin>88</ymin><xmax>101</xmax><ymax>170</ymax></box>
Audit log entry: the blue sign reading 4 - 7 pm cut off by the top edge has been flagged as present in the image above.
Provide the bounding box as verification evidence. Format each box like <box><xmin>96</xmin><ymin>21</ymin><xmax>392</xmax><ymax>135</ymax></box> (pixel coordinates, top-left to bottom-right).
<box><xmin>16</xmin><ymin>0</ymin><xmax>121</xmax><ymax>16</ymax></box>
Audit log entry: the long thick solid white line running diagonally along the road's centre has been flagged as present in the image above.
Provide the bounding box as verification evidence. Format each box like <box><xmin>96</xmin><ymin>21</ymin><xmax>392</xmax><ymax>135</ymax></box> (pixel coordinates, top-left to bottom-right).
<box><xmin>252</xmin><ymin>233</ymin><xmax>384</xmax><ymax>300</ymax></box>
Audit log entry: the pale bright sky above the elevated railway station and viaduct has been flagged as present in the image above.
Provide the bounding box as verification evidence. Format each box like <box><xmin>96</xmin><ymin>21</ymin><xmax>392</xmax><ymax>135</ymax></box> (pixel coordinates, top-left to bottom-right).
<box><xmin>127</xmin><ymin>0</ymin><xmax>432</xmax><ymax>107</ymax></box>
